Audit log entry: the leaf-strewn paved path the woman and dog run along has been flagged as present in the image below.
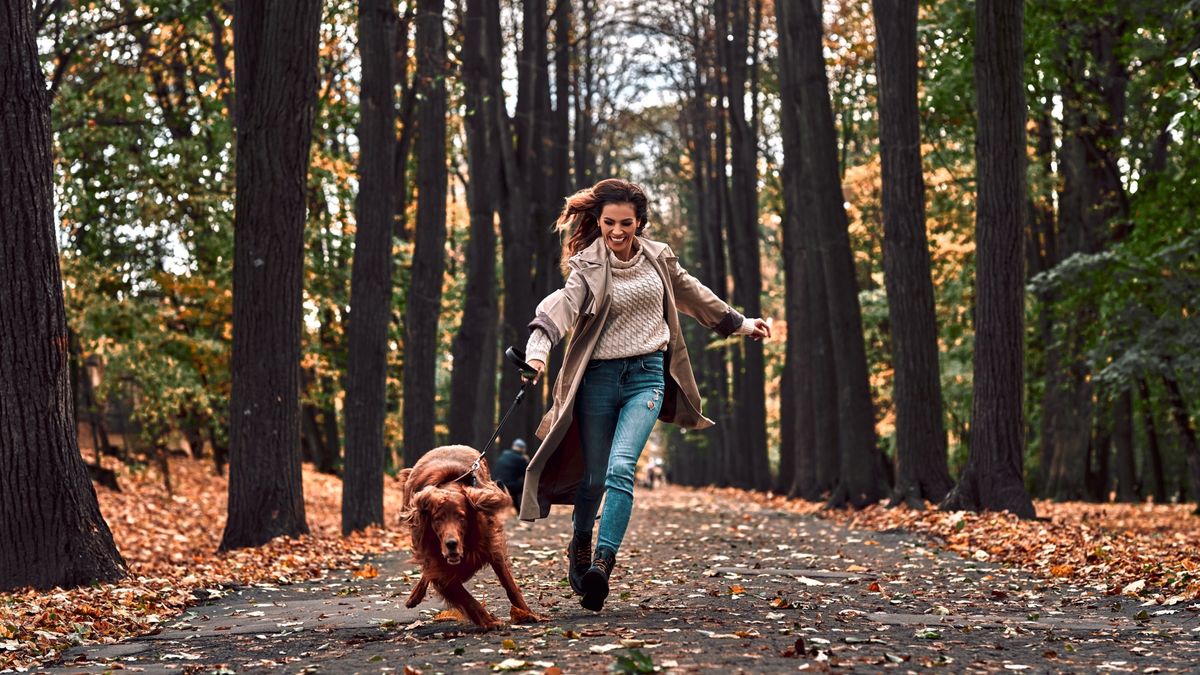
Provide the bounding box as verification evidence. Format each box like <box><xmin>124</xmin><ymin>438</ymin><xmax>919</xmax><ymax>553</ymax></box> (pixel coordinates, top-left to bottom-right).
<box><xmin>50</xmin><ymin>486</ymin><xmax>1200</xmax><ymax>674</ymax></box>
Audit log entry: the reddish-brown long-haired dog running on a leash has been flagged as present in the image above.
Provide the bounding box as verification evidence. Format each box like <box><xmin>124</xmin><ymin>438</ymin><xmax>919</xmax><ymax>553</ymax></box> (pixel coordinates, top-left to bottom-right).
<box><xmin>400</xmin><ymin>446</ymin><xmax>541</xmax><ymax>631</ymax></box>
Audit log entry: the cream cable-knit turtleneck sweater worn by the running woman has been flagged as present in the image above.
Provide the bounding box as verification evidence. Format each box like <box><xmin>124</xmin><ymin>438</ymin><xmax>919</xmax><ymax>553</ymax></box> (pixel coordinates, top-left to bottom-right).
<box><xmin>526</xmin><ymin>249</ymin><xmax>754</xmax><ymax>363</ymax></box>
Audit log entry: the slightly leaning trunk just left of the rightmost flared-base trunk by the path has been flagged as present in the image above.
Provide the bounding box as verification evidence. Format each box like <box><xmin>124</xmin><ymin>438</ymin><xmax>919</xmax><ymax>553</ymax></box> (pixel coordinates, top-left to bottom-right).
<box><xmin>874</xmin><ymin>0</ymin><xmax>954</xmax><ymax>508</ymax></box>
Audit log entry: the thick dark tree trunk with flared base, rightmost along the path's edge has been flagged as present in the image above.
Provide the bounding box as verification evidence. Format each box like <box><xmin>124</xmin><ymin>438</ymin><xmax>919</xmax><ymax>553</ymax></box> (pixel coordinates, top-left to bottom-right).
<box><xmin>941</xmin><ymin>0</ymin><xmax>1036</xmax><ymax>518</ymax></box>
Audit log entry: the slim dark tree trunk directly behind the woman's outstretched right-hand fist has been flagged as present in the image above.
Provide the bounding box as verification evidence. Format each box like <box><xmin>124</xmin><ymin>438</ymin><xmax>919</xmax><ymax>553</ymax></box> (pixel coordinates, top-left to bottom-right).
<box><xmin>716</xmin><ymin>0</ymin><xmax>770</xmax><ymax>490</ymax></box>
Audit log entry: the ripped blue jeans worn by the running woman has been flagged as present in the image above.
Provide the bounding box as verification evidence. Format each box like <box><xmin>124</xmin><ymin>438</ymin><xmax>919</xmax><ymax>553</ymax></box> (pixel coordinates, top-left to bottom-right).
<box><xmin>572</xmin><ymin>352</ymin><xmax>664</xmax><ymax>554</ymax></box>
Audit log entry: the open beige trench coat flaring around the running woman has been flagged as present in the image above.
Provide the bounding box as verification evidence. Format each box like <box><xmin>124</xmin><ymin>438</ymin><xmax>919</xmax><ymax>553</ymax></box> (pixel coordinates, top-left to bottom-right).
<box><xmin>520</xmin><ymin>238</ymin><xmax>743</xmax><ymax>520</ymax></box>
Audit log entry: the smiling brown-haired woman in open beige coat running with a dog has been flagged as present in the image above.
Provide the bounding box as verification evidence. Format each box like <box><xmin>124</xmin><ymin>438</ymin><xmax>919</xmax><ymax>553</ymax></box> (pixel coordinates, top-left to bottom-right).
<box><xmin>521</xmin><ymin>179</ymin><xmax>770</xmax><ymax>611</ymax></box>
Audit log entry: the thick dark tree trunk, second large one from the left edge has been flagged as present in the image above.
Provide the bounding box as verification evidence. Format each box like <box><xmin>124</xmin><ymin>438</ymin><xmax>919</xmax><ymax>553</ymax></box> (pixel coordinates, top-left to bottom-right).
<box><xmin>221</xmin><ymin>0</ymin><xmax>320</xmax><ymax>550</ymax></box>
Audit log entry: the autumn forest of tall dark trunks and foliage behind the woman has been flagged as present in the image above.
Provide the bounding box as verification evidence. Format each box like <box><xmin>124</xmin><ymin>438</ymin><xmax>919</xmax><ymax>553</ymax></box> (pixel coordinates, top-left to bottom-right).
<box><xmin>0</xmin><ymin>0</ymin><xmax>1200</xmax><ymax>619</ymax></box>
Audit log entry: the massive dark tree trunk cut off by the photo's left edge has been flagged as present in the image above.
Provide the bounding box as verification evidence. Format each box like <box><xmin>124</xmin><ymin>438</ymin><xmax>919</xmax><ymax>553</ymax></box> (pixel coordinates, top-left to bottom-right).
<box><xmin>0</xmin><ymin>1</ymin><xmax>125</xmax><ymax>591</ymax></box>
